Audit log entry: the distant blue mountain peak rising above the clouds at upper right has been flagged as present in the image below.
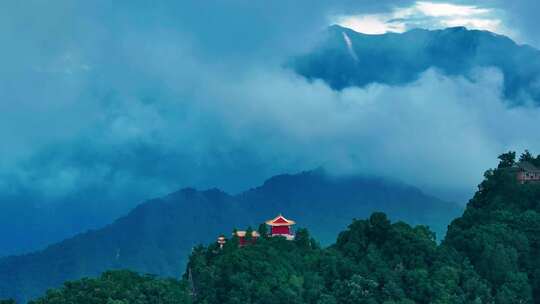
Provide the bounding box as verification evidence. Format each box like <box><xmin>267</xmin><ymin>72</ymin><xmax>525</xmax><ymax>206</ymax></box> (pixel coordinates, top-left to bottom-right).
<box><xmin>289</xmin><ymin>25</ymin><xmax>540</xmax><ymax>104</ymax></box>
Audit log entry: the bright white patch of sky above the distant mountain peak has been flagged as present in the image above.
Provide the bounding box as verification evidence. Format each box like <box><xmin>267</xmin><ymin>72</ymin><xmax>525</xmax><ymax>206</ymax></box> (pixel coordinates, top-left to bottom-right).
<box><xmin>334</xmin><ymin>1</ymin><xmax>515</xmax><ymax>37</ymax></box>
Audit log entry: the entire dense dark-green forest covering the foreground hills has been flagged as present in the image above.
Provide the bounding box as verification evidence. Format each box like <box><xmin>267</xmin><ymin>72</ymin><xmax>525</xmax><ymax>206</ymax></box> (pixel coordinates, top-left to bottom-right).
<box><xmin>7</xmin><ymin>152</ymin><xmax>540</xmax><ymax>304</ymax></box>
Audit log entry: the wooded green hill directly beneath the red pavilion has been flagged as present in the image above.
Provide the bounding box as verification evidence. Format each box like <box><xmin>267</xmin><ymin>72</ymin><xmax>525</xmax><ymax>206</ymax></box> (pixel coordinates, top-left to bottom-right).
<box><xmin>188</xmin><ymin>213</ymin><xmax>490</xmax><ymax>304</ymax></box>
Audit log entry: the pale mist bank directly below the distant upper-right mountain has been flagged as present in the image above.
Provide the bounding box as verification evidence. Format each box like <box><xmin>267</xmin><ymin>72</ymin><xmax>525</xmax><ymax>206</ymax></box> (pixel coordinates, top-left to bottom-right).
<box><xmin>190</xmin><ymin>69</ymin><xmax>540</xmax><ymax>195</ymax></box>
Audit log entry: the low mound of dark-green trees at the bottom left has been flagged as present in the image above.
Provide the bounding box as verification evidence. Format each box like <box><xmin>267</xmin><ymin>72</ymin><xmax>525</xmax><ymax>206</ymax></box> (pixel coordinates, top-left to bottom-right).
<box><xmin>28</xmin><ymin>270</ymin><xmax>191</xmax><ymax>304</ymax></box>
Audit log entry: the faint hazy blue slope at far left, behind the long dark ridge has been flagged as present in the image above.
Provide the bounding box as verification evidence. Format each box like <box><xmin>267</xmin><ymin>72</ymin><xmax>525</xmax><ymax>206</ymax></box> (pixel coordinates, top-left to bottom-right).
<box><xmin>0</xmin><ymin>194</ymin><xmax>132</xmax><ymax>257</ymax></box>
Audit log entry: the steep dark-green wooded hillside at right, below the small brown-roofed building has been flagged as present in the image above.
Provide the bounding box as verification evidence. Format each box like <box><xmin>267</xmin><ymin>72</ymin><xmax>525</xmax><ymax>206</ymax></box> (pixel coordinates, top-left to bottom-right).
<box><xmin>444</xmin><ymin>151</ymin><xmax>540</xmax><ymax>303</ymax></box>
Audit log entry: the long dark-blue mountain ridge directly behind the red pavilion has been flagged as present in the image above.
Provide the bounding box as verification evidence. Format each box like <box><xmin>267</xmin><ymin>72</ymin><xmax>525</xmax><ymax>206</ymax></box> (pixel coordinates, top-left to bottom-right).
<box><xmin>0</xmin><ymin>170</ymin><xmax>461</xmax><ymax>301</ymax></box>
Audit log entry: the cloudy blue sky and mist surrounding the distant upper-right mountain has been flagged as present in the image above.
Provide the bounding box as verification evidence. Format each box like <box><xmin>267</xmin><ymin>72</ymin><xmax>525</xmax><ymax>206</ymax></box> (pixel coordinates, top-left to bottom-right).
<box><xmin>0</xmin><ymin>0</ymin><xmax>540</xmax><ymax>242</ymax></box>
